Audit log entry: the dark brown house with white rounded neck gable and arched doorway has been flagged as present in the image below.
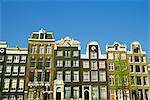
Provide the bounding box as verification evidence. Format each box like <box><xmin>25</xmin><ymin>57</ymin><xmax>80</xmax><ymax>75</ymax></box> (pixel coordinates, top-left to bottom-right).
<box><xmin>80</xmin><ymin>41</ymin><xmax>109</xmax><ymax>100</ymax></box>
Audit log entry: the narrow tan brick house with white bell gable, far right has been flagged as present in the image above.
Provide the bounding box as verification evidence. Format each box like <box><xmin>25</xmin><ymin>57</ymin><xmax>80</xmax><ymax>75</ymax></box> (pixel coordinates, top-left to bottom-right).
<box><xmin>128</xmin><ymin>41</ymin><xmax>150</xmax><ymax>100</ymax></box>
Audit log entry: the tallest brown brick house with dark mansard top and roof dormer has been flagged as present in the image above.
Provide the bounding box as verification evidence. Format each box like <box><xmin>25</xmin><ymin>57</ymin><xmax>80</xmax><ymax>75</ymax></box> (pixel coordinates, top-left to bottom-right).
<box><xmin>24</xmin><ymin>28</ymin><xmax>55</xmax><ymax>100</ymax></box>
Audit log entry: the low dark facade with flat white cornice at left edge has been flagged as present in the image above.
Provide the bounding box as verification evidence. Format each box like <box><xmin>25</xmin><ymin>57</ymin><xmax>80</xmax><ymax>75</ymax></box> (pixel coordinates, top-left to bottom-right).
<box><xmin>0</xmin><ymin>42</ymin><xmax>28</xmax><ymax>100</ymax></box>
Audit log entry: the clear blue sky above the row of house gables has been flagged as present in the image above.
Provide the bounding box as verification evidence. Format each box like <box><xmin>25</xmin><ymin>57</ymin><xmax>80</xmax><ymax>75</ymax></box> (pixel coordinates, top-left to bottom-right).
<box><xmin>0</xmin><ymin>0</ymin><xmax>150</xmax><ymax>57</ymax></box>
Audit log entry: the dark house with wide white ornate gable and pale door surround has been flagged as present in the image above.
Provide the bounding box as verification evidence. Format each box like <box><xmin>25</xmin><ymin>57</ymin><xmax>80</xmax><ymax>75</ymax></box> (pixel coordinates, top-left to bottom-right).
<box><xmin>54</xmin><ymin>37</ymin><xmax>82</xmax><ymax>100</ymax></box>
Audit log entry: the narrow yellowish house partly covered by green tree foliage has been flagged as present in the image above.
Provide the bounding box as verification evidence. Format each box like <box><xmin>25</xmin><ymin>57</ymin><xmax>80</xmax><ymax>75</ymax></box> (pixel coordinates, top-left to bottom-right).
<box><xmin>106</xmin><ymin>42</ymin><xmax>130</xmax><ymax>100</ymax></box>
